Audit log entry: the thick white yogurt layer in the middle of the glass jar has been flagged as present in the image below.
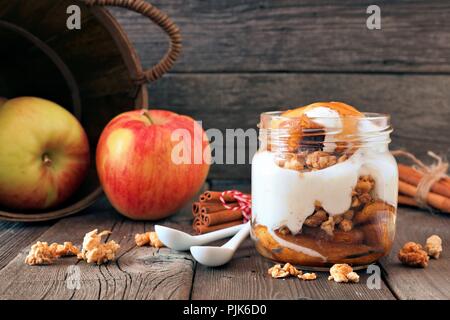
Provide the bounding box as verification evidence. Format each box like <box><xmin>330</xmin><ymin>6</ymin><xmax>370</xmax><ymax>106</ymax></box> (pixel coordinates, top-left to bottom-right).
<box><xmin>252</xmin><ymin>146</ymin><xmax>398</xmax><ymax>234</ymax></box>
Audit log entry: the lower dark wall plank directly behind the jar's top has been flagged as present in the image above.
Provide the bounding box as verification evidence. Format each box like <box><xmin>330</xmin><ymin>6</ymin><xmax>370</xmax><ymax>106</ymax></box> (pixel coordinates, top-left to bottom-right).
<box><xmin>149</xmin><ymin>73</ymin><xmax>450</xmax><ymax>179</ymax></box>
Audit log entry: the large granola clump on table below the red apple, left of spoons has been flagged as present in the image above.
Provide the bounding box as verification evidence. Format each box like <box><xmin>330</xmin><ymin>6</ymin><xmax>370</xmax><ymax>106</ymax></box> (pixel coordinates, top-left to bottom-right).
<box><xmin>78</xmin><ymin>229</ymin><xmax>120</xmax><ymax>264</ymax></box>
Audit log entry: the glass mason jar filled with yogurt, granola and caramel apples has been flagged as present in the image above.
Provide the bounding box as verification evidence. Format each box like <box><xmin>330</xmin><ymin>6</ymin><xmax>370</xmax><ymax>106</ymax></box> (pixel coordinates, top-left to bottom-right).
<box><xmin>251</xmin><ymin>112</ymin><xmax>398</xmax><ymax>267</ymax></box>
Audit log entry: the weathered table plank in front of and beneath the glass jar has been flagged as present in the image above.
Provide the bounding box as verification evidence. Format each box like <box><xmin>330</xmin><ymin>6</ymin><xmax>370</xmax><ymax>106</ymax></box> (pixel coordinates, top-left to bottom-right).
<box><xmin>192</xmin><ymin>239</ymin><xmax>394</xmax><ymax>300</ymax></box>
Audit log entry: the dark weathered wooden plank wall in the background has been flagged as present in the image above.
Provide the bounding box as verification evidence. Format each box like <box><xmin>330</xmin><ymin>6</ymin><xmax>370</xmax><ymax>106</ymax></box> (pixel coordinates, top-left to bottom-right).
<box><xmin>113</xmin><ymin>0</ymin><xmax>450</xmax><ymax>179</ymax></box>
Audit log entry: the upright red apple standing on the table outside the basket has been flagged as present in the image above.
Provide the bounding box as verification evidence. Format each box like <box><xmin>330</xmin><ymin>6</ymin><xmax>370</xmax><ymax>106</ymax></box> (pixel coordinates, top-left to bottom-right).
<box><xmin>96</xmin><ymin>110</ymin><xmax>210</xmax><ymax>220</ymax></box>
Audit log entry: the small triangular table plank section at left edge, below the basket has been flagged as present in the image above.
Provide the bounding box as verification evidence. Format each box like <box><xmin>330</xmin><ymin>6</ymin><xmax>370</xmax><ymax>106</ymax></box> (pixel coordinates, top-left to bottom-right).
<box><xmin>0</xmin><ymin>221</ymin><xmax>53</xmax><ymax>270</ymax></box>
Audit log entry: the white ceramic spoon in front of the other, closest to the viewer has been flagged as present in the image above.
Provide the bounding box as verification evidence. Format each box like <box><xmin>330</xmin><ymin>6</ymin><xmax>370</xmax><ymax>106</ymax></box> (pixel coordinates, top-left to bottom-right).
<box><xmin>191</xmin><ymin>222</ymin><xmax>250</xmax><ymax>267</ymax></box>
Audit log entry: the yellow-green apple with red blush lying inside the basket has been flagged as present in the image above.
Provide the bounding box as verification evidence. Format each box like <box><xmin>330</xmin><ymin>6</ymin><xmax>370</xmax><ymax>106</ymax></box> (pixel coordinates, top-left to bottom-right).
<box><xmin>0</xmin><ymin>97</ymin><xmax>89</xmax><ymax>209</ymax></box>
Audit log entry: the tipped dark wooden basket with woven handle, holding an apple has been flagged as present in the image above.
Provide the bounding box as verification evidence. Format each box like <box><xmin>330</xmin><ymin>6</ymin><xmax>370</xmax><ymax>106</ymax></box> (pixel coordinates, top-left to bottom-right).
<box><xmin>0</xmin><ymin>0</ymin><xmax>181</xmax><ymax>222</ymax></box>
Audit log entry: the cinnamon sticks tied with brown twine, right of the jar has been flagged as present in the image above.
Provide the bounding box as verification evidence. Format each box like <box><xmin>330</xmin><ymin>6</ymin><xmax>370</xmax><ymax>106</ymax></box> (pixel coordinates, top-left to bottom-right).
<box><xmin>398</xmin><ymin>164</ymin><xmax>450</xmax><ymax>213</ymax></box>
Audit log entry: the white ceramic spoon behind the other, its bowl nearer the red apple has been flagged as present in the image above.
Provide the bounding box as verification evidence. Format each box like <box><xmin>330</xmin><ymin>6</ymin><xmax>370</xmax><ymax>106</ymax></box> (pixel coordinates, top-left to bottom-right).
<box><xmin>155</xmin><ymin>224</ymin><xmax>245</xmax><ymax>251</ymax></box>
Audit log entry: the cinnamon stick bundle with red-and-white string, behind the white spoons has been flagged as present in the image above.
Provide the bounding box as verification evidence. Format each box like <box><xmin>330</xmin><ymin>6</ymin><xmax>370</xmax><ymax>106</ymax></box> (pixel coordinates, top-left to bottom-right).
<box><xmin>192</xmin><ymin>191</ymin><xmax>244</xmax><ymax>234</ymax></box>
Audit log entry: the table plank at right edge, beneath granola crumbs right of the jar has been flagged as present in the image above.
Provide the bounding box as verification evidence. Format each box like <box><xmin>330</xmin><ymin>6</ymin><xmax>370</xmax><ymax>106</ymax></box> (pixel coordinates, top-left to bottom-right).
<box><xmin>381</xmin><ymin>207</ymin><xmax>450</xmax><ymax>300</ymax></box>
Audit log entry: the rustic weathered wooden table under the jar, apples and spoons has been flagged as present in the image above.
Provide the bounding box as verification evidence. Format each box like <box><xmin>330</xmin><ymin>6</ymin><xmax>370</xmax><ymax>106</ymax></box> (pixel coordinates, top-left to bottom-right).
<box><xmin>0</xmin><ymin>182</ymin><xmax>450</xmax><ymax>300</ymax></box>
